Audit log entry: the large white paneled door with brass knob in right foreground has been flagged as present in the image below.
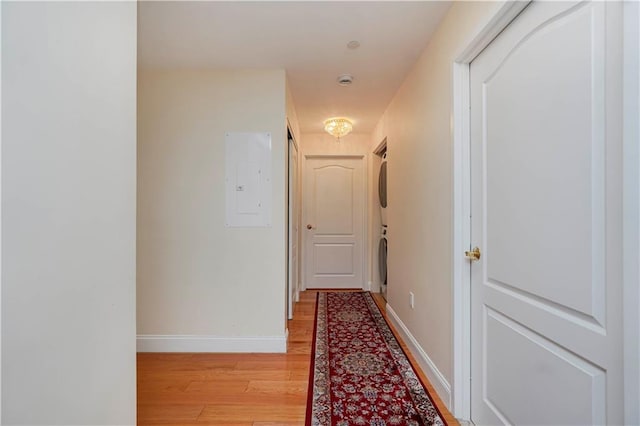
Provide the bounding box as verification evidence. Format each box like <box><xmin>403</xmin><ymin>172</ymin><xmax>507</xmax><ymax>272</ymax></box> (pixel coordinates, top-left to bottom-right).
<box><xmin>471</xmin><ymin>2</ymin><xmax>623</xmax><ymax>425</ymax></box>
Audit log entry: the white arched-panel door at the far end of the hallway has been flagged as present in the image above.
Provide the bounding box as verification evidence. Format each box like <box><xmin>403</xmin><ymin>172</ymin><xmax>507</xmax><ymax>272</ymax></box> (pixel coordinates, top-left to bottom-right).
<box><xmin>302</xmin><ymin>156</ymin><xmax>365</xmax><ymax>288</ymax></box>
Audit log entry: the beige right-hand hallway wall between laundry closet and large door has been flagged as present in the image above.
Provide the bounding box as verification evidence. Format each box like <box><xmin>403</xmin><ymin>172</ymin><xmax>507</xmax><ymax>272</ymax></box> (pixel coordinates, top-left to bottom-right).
<box><xmin>372</xmin><ymin>2</ymin><xmax>499</xmax><ymax>400</ymax></box>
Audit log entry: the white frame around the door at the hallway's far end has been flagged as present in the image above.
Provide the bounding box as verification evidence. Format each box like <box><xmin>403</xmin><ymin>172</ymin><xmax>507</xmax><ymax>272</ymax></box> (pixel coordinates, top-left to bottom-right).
<box><xmin>299</xmin><ymin>154</ymin><xmax>371</xmax><ymax>291</ymax></box>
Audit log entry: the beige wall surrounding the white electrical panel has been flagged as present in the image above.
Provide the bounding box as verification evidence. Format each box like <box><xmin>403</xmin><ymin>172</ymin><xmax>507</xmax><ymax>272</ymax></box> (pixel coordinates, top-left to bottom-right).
<box><xmin>138</xmin><ymin>70</ymin><xmax>286</xmax><ymax>351</ymax></box>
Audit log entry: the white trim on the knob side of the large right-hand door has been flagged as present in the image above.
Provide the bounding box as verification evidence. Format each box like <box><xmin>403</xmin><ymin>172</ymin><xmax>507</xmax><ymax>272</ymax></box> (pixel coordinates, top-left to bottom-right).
<box><xmin>451</xmin><ymin>1</ymin><xmax>529</xmax><ymax>420</ymax></box>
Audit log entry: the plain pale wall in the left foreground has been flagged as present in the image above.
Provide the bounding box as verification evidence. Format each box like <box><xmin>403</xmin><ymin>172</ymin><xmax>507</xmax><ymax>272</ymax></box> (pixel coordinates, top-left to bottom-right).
<box><xmin>1</xmin><ymin>2</ymin><xmax>137</xmax><ymax>425</ymax></box>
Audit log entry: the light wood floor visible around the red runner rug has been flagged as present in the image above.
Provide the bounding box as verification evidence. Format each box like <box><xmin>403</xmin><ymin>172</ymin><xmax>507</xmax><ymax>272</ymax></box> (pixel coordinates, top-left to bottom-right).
<box><xmin>138</xmin><ymin>291</ymin><xmax>457</xmax><ymax>426</ymax></box>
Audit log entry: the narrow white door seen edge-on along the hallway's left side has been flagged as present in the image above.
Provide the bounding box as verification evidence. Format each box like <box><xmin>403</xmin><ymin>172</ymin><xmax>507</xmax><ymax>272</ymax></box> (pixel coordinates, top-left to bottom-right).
<box><xmin>287</xmin><ymin>139</ymin><xmax>300</xmax><ymax>319</ymax></box>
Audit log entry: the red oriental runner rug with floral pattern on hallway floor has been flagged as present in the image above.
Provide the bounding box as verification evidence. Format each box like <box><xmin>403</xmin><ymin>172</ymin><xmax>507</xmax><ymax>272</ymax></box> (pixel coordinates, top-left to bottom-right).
<box><xmin>305</xmin><ymin>292</ymin><xmax>446</xmax><ymax>426</ymax></box>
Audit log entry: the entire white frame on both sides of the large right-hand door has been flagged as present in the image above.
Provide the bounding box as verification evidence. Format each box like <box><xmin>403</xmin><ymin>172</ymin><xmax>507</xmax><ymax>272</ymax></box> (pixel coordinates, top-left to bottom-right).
<box><xmin>451</xmin><ymin>1</ymin><xmax>640</xmax><ymax>424</ymax></box>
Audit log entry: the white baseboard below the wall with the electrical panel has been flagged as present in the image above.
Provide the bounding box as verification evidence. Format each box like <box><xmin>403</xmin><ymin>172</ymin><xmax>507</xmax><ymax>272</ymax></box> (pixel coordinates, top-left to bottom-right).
<box><xmin>136</xmin><ymin>334</ymin><xmax>287</xmax><ymax>353</ymax></box>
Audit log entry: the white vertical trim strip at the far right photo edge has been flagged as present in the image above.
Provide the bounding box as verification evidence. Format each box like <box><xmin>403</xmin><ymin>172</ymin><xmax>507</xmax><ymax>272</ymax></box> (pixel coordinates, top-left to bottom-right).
<box><xmin>622</xmin><ymin>2</ymin><xmax>640</xmax><ymax>425</ymax></box>
